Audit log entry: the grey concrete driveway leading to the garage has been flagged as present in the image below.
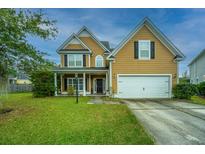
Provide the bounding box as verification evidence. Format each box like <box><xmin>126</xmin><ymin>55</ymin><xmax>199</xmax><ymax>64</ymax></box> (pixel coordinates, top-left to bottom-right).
<box><xmin>124</xmin><ymin>100</ymin><xmax>205</xmax><ymax>144</ymax></box>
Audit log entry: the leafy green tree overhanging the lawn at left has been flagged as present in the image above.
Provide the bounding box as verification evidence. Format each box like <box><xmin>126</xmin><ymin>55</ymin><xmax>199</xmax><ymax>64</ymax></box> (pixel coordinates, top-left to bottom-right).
<box><xmin>0</xmin><ymin>9</ymin><xmax>58</xmax><ymax>95</ymax></box>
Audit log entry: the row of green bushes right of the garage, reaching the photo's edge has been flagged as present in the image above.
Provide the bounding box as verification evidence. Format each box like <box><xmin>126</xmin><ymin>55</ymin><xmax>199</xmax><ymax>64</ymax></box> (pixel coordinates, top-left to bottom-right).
<box><xmin>173</xmin><ymin>82</ymin><xmax>205</xmax><ymax>99</ymax></box>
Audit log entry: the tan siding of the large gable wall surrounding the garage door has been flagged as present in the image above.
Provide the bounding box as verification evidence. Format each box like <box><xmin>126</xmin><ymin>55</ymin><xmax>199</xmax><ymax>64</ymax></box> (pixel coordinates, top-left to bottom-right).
<box><xmin>112</xmin><ymin>26</ymin><xmax>177</xmax><ymax>93</ymax></box>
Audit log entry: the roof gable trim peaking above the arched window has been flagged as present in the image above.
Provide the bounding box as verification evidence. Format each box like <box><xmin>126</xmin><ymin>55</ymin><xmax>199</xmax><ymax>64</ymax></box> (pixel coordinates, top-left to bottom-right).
<box><xmin>77</xmin><ymin>26</ymin><xmax>110</xmax><ymax>52</ymax></box>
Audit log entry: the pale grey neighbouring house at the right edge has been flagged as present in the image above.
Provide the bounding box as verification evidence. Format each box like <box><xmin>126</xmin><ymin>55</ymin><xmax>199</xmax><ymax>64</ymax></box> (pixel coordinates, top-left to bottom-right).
<box><xmin>188</xmin><ymin>49</ymin><xmax>205</xmax><ymax>84</ymax></box>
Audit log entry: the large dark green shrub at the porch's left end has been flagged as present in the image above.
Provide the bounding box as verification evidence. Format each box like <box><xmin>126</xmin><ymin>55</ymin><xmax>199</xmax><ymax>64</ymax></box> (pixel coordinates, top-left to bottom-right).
<box><xmin>30</xmin><ymin>70</ymin><xmax>55</xmax><ymax>97</ymax></box>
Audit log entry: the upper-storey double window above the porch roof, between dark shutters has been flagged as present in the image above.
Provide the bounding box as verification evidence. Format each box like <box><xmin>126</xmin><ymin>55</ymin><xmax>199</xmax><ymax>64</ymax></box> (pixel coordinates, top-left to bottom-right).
<box><xmin>68</xmin><ymin>54</ymin><xmax>83</xmax><ymax>67</ymax></box>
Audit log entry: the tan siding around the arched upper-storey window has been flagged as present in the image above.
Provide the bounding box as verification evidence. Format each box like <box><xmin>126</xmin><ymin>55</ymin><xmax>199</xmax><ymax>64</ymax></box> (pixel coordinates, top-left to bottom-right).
<box><xmin>80</xmin><ymin>37</ymin><xmax>108</xmax><ymax>67</ymax></box>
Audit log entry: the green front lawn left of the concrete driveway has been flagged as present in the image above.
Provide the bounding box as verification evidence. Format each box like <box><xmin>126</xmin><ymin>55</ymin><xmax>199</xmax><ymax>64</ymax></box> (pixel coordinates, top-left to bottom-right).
<box><xmin>0</xmin><ymin>93</ymin><xmax>154</xmax><ymax>144</ymax></box>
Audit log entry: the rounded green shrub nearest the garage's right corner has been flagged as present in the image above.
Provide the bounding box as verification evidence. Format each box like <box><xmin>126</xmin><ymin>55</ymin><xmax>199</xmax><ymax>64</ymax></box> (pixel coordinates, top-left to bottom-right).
<box><xmin>173</xmin><ymin>84</ymin><xmax>198</xmax><ymax>99</ymax></box>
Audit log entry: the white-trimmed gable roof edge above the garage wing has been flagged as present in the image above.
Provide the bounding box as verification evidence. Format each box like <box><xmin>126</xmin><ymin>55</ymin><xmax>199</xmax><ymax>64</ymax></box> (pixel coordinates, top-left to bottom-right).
<box><xmin>108</xmin><ymin>18</ymin><xmax>185</xmax><ymax>60</ymax></box>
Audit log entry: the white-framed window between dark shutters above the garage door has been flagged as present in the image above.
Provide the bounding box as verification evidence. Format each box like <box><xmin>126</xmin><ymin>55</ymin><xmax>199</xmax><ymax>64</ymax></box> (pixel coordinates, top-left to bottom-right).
<box><xmin>139</xmin><ymin>40</ymin><xmax>150</xmax><ymax>60</ymax></box>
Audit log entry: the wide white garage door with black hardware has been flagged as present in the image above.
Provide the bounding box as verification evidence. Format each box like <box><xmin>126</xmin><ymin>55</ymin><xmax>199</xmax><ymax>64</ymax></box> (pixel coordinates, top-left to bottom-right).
<box><xmin>118</xmin><ymin>75</ymin><xmax>170</xmax><ymax>98</ymax></box>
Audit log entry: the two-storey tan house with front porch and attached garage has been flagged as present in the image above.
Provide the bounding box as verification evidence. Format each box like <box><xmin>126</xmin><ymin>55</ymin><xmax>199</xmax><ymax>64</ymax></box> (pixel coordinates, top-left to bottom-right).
<box><xmin>54</xmin><ymin>18</ymin><xmax>185</xmax><ymax>98</ymax></box>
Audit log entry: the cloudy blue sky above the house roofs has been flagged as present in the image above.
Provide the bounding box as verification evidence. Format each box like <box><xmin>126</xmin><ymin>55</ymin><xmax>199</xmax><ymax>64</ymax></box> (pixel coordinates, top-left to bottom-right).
<box><xmin>29</xmin><ymin>9</ymin><xmax>205</xmax><ymax>74</ymax></box>
